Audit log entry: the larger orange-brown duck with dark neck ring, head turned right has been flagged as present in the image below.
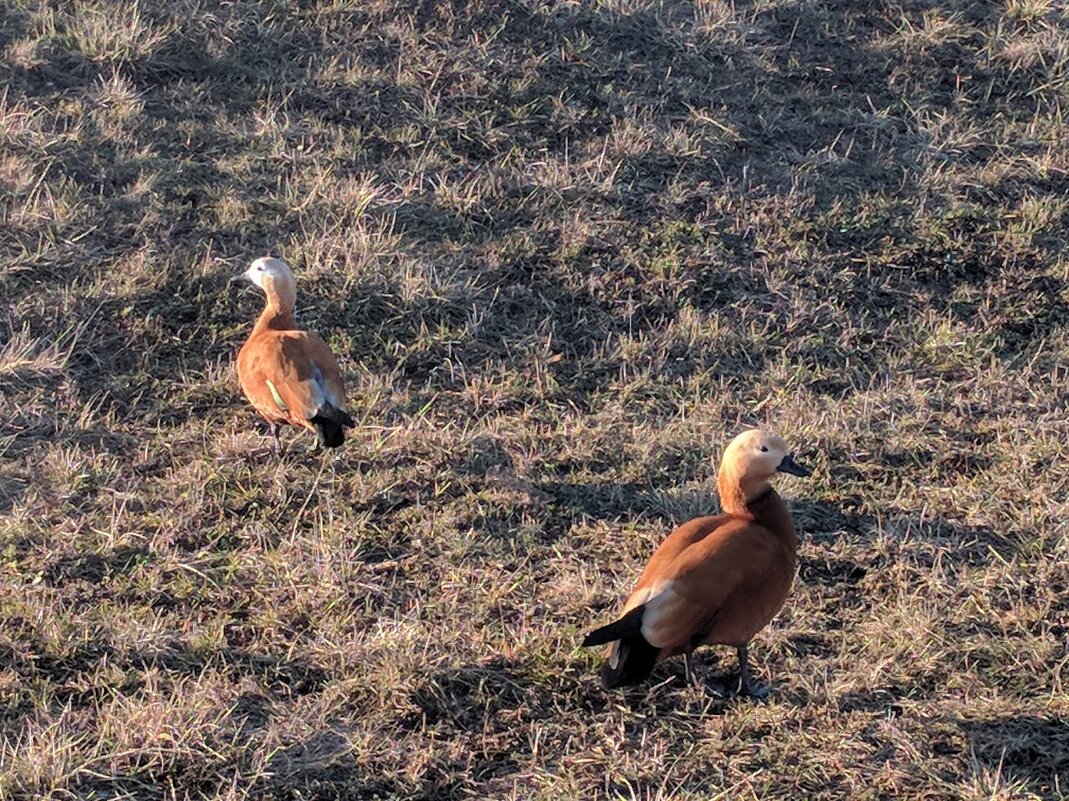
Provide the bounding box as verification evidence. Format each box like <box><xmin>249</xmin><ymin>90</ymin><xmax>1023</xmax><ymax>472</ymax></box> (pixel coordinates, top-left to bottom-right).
<box><xmin>583</xmin><ymin>429</ymin><xmax>811</xmax><ymax>697</ymax></box>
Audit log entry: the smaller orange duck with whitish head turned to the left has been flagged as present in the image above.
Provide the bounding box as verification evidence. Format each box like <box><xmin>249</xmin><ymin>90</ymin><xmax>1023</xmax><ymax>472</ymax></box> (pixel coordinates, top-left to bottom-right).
<box><xmin>231</xmin><ymin>258</ymin><xmax>356</xmax><ymax>455</ymax></box>
